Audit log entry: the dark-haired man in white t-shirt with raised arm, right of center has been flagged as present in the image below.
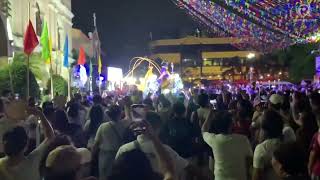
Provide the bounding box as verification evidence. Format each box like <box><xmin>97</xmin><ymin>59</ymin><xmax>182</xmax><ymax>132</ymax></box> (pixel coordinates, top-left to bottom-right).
<box><xmin>202</xmin><ymin>111</ymin><xmax>253</xmax><ymax>180</ymax></box>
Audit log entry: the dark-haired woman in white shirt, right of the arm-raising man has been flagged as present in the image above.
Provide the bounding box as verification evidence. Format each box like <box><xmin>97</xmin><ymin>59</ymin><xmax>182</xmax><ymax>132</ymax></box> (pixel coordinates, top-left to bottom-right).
<box><xmin>252</xmin><ymin>110</ymin><xmax>283</xmax><ymax>180</ymax></box>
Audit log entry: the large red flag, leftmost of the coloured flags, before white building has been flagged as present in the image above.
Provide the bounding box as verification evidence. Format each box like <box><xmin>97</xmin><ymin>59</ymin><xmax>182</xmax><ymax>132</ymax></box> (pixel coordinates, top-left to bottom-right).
<box><xmin>23</xmin><ymin>20</ymin><xmax>39</xmax><ymax>55</ymax></box>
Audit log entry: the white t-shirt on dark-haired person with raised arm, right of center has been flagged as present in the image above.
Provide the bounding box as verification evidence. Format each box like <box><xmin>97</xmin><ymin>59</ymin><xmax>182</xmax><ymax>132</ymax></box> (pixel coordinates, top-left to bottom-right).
<box><xmin>202</xmin><ymin>132</ymin><xmax>252</xmax><ymax>180</ymax></box>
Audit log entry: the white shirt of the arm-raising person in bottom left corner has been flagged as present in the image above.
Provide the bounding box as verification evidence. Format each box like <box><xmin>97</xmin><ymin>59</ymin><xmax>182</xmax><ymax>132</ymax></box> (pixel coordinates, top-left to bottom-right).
<box><xmin>0</xmin><ymin>141</ymin><xmax>48</xmax><ymax>180</ymax></box>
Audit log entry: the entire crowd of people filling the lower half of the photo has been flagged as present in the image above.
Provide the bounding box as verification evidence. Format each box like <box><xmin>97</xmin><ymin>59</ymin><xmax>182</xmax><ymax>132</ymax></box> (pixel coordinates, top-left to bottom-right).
<box><xmin>0</xmin><ymin>84</ymin><xmax>320</xmax><ymax>180</ymax></box>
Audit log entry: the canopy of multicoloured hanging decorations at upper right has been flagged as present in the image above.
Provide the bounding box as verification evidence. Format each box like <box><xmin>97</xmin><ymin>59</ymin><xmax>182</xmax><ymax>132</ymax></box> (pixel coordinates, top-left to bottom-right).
<box><xmin>174</xmin><ymin>0</ymin><xmax>320</xmax><ymax>52</ymax></box>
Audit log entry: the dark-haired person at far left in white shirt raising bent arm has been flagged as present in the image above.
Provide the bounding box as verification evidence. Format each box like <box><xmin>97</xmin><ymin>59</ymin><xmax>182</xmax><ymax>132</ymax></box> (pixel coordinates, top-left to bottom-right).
<box><xmin>0</xmin><ymin>108</ymin><xmax>54</xmax><ymax>180</ymax></box>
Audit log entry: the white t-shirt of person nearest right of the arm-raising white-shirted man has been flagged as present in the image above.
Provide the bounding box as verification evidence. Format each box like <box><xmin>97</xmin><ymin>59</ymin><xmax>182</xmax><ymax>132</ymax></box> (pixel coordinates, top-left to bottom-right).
<box><xmin>253</xmin><ymin>138</ymin><xmax>281</xmax><ymax>180</ymax></box>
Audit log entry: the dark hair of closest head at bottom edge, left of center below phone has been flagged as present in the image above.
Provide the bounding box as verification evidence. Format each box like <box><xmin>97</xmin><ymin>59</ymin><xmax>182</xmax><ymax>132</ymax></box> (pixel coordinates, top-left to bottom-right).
<box><xmin>108</xmin><ymin>149</ymin><xmax>162</xmax><ymax>180</ymax></box>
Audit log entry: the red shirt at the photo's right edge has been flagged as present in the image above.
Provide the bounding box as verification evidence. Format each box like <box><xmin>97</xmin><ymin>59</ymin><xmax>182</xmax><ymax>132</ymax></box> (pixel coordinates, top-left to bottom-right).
<box><xmin>311</xmin><ymin>132</ymin><xmax>320</xmax><ymax>176</ymax></box>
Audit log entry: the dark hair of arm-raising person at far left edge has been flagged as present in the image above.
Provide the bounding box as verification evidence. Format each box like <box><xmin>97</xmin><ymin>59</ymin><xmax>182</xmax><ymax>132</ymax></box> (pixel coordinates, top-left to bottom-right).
<box><xmin>2</xmin><ymin>126</ymin><xmax>28</xmax><ymax>157</ymax></box>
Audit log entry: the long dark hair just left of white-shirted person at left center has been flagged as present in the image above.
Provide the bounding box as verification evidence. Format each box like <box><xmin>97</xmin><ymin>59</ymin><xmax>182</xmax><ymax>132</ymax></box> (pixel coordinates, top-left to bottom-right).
<box><xmin>89</xmin><ymin>105</ymin><xmax>104</xmax><ymax>135</ymax></box>
